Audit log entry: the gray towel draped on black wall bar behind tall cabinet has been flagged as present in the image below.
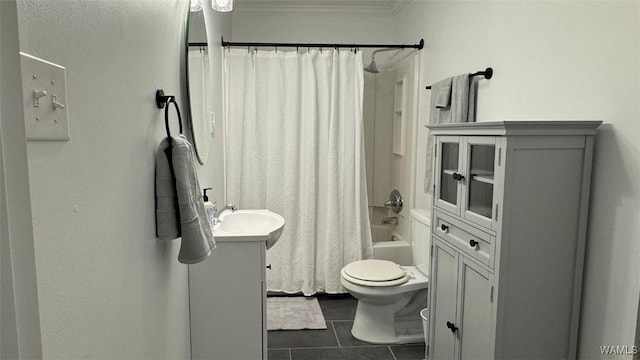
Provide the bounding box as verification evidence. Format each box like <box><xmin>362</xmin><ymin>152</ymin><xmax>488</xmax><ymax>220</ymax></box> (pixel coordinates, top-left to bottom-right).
<box><xmin>424</xmin><ymin>74</ymin><xmax>477</xmax><ymax>194</ymax></box>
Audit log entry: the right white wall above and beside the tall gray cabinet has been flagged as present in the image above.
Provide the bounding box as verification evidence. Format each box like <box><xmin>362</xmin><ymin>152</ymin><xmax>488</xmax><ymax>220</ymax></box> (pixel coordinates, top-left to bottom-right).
<box><xmin>395</xmin><ymin>0</ymin><xmax>640</xmax><ymax>358</ymax></box>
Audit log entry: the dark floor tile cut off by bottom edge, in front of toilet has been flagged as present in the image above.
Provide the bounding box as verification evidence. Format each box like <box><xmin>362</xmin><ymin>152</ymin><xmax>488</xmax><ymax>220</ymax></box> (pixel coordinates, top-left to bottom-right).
<box><xmin>291</xmin><ymin>346</ymin><xmax>394</xmax><ymax>360</ymax></box>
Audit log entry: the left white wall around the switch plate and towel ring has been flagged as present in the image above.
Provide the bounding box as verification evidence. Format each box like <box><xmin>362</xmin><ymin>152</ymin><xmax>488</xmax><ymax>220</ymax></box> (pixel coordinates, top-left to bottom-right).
<box><xmin>15</xmin><ymin>0</ymin><xmax>230</xmax><ymax>359</ymax></box>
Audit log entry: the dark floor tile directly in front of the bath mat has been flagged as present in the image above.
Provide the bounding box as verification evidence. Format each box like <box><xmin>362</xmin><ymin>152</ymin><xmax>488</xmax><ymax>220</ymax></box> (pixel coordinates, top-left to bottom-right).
<box><xmin>267</xmin><ymin>323</ymin><xmax>338</xmax><ymax>349</ymax></box>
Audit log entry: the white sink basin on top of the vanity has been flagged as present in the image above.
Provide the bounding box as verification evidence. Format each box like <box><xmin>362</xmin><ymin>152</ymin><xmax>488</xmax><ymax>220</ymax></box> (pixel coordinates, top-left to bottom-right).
<box><xmin>212</xmin><ymin>210</ymin><xmax>284</xmax><ymax>249</ymax></box>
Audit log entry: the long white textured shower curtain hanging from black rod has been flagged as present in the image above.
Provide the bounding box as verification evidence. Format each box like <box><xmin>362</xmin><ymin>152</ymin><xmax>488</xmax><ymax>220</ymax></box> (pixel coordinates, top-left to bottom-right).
<box><xmin>224</xmin><ymin>49</ymin><xmax>372</xmax><ymax>295</ymax></box>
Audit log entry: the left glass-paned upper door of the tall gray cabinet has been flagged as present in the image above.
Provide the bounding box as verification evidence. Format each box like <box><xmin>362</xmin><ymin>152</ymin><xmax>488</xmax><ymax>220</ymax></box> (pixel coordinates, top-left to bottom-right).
<box><xmin>436</xmin><ymin>136</ymin><xmax>461</xmax><ymax>213</ymax></box>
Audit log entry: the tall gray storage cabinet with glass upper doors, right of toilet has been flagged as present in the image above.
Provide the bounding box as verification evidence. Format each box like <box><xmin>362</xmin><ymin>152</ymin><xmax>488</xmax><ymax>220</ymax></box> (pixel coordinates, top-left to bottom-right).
<box><xmin>427</xmin><ymin>121</ymin><xmax>601</xmax><ymax>359</ymax></box>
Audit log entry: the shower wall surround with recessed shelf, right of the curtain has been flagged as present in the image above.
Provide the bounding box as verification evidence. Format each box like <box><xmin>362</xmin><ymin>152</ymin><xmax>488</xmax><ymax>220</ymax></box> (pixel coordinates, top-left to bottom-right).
<box><xmin>364</xmin><ymin>53</ymin><xmax>424</xmax><ymax>241</ymax></box>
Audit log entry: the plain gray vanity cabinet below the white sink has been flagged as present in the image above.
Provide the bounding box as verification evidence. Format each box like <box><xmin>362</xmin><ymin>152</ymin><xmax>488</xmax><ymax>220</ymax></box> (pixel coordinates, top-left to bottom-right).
<box><xmin>189</xmin><ymin>239</ymin><xmax>267</xmax><ymax>360</ymax></box>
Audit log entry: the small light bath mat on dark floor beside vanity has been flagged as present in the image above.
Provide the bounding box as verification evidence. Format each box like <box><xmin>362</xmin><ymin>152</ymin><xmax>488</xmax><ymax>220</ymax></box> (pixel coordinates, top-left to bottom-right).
<box><xmin>267</xmin><ymin>297</ymin><xmax>327</xmax><ymax>330</ymax></box>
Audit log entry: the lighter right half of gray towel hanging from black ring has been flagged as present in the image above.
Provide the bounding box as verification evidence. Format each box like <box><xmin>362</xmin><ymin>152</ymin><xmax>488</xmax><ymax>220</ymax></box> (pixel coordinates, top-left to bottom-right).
<box><xmin>171</xmin><ymin>135</ymin><xmax>216</xmax><ymax>264</ymax></box>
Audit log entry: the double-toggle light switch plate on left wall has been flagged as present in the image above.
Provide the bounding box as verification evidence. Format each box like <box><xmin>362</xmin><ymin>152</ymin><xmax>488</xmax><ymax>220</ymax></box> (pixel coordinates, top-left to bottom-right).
<box><xmin>20</xmin><ymin>52</ymin><xmax>70</xmax><ymax>141</ymax></box>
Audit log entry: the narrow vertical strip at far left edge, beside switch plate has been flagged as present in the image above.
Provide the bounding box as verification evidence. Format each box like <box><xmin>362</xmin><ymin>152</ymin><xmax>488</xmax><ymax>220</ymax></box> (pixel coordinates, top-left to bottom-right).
<box><xmin>0</xmin><ymin>0</ymin><xmax>42</xmax><ymax>359</ymax></box>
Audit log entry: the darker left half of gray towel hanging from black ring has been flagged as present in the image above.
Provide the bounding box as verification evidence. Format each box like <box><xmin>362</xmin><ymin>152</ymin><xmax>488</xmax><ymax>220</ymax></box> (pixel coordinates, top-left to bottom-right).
<box><xmin>155</xmin><ymin>138</ymin><xmax>180</xmax><ymax>240</ymax></box>
